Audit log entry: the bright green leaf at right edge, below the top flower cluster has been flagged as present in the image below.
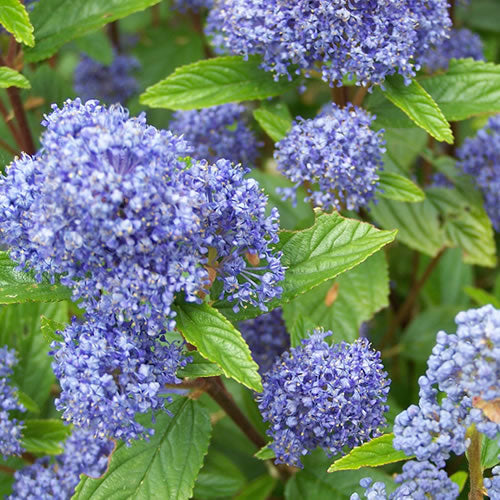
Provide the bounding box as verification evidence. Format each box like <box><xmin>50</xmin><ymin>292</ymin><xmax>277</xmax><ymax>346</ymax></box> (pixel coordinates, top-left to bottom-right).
<box><xmin>420</xmin><ymin>59</ymin><xmax>500</xmax><ymax>121</ymax></box>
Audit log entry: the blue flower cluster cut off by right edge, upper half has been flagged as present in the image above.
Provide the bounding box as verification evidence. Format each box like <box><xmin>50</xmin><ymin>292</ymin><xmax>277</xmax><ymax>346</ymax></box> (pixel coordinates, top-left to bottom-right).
<box><xmin>457</xmin><ymin>115</ymin><xmax>500</xmax><ymax>231</ymax></box>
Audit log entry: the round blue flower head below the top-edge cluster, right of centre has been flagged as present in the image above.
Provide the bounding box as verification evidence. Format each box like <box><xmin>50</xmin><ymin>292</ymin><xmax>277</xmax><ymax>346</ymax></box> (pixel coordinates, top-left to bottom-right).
<box><xmin>274</xmin><ymin>104</ymin><xmax>385</xmax><ymax>210</ymax></box>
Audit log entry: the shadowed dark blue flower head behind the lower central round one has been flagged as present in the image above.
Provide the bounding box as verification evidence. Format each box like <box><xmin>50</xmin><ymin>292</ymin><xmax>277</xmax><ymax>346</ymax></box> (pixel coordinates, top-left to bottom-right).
<box><xmin>239</xmin><ymin>309</ymin><xmax>290</xmax><ymax>374</ymax></box>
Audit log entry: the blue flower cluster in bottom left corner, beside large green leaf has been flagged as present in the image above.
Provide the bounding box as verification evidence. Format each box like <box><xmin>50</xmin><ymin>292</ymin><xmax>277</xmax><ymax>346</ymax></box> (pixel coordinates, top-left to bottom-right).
<box><xmin>7</xmin><ymin>429</ymin><xmax>114</xmax><ymax>500</ymax></box>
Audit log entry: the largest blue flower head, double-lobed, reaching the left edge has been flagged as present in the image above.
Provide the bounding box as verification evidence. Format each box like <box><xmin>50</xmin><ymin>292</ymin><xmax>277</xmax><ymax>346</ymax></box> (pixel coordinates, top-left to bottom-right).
<box><xmin>0</xmin><ymin>99</ymin><xmax>283</xmax><ymax>335</ymax></box>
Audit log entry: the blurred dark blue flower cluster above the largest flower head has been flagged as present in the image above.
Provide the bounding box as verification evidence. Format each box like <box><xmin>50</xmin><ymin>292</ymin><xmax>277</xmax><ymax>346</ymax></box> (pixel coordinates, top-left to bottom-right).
<box><xmin>73</xmin><ymin>53</ymin><xmax>141</xmax><ymax>104</ymax></box>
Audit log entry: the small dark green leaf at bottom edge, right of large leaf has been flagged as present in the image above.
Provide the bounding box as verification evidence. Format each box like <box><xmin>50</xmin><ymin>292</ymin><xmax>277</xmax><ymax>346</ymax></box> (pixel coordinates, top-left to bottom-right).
<box><xmin>193</xmin><ymin>449</ymin><xmax>246</xmax><ymax>499</ymax></box>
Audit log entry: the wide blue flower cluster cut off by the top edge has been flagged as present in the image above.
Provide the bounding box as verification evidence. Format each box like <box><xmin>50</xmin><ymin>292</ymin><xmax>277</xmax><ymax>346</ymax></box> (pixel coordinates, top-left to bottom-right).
<box><xmin>207</xmin><ymin>0</ymin><xmax>451</xmax><ymax>85</ymax></box>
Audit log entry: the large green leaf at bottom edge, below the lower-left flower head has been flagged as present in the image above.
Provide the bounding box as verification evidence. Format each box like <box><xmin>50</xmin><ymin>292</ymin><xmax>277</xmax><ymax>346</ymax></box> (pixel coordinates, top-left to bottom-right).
<box><xmin>73</xmin><ymin>398</ymin><xmax>210</xmax><ymax>500</ymax></box>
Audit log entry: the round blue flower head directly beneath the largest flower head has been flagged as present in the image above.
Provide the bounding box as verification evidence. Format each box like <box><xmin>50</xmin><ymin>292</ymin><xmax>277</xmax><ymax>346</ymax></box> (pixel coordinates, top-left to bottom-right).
<box><xmin>52</xmin><ymin>315</ymin><xmax>190</xmax><ymax>442</ymax></box>
